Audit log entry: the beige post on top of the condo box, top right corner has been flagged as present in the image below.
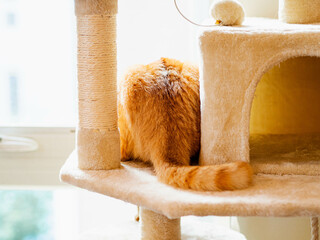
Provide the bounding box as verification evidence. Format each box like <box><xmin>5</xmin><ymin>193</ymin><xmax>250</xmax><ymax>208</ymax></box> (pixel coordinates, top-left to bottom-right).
<box><xmin>279</xmin><ymin>0</ymin><xmax>320</xmax><ymax>23</ymax></box>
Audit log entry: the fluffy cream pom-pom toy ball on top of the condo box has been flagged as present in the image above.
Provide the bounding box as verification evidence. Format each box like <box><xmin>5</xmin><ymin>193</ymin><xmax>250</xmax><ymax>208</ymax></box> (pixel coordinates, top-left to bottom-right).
<box><xmin>210</xmin><ymin>0</ymin><xmax>245</xmax><ymax>26</ymax></box>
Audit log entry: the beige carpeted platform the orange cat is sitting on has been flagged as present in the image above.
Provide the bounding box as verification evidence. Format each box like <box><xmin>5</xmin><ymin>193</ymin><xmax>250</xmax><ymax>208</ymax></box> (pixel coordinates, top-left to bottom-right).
<box><xmin>61</xmin><ymin>152</ymin><xmax>320</xmax><ymax>218</ymax></box>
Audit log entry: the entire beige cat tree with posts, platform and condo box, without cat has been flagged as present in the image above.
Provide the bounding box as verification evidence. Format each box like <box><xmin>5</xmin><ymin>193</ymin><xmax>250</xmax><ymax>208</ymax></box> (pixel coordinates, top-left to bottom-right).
<box><xmin>61</xmin><ymin>0</ymin><xmax>320</xmax><ymax>240</ymax></box>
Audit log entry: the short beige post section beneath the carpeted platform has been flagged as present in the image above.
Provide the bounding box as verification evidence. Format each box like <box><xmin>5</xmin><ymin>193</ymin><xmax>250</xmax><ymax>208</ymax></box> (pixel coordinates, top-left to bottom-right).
<box><xmin>140</xmin><ymin>208</ymin><xmax>181</xmax><ymax>240</ymax></box>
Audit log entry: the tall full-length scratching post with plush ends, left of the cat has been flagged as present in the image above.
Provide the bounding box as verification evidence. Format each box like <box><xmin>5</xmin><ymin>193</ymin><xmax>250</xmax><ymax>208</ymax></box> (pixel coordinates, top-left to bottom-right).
<box><xmin>75</xmin><ymin>0</ymin><xmax>120</xmax><ymax>170</ymax></box>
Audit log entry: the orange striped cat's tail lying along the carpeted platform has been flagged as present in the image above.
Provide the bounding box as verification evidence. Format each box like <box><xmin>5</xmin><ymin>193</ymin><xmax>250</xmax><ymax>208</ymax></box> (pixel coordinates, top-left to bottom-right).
<box><xmin>155</xmin><ymin>161</ymin><xmax>253</xmax><ymax>191</ymax></box>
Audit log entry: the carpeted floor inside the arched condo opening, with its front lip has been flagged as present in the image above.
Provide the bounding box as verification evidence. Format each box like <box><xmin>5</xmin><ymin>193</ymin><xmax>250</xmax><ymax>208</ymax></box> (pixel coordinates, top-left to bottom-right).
<box><xmin>250</xmin><ymin>134</ymin><xmax>320</xmax><ymax>175</ymax></box>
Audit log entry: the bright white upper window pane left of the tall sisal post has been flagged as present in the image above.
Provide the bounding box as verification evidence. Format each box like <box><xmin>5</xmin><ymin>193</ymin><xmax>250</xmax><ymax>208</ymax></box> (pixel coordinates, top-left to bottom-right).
<box><xmin>0</xmin><ymin>0</ymin><xmax>76</xmax><ymax>126</ymax></box>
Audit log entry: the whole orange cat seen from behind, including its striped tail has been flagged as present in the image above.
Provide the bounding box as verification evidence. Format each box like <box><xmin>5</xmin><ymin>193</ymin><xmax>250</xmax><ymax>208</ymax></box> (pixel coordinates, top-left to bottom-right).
<box><xmin>118</xmin><ymin>58</ymin><xmax>252</xmax><ymax>191</ymax></box>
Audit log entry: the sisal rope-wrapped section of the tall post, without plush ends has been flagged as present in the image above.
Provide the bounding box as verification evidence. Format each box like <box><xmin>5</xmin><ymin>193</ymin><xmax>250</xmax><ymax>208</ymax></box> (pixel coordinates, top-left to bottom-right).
<box><xmin>77</xmin><ymin>15</ymin><xmax>118</xmax><ymax>131</ymax></box>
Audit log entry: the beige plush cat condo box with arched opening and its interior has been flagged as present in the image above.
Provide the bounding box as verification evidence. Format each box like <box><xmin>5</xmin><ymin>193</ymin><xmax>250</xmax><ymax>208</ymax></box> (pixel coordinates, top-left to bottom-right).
<box><xmin>200</xmin><ymin>18</ymin><xmax>320</xmax><ymax>175</ymax></box>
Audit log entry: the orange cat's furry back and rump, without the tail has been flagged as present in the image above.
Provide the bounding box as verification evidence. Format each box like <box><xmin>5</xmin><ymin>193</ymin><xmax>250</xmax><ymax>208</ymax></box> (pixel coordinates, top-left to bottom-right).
<box><xmin>119</xmin><ymin>58</ymin><xmax>200</xmax><ymax>162</ymax></box>
